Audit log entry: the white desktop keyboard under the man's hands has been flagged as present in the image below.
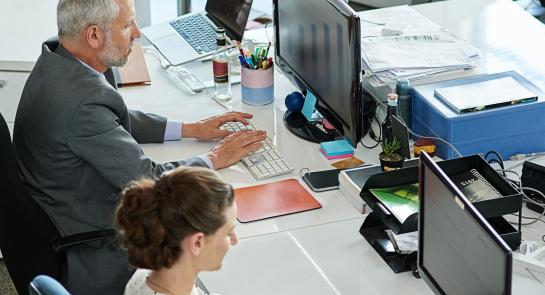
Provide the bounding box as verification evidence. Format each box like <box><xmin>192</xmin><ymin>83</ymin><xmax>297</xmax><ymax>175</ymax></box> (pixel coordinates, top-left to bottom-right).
<box><xmin>222</xmin><ymin>121</ymin><xmax>293</xmax><ymax>180</ymax></box>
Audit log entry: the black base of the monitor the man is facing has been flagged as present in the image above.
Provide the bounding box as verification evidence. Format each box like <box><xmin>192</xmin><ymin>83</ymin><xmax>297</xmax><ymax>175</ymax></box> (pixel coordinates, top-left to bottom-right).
<box><xmin>284</xmin><ymin>110</ymin><xmax>340</xmax><ymax>143</ymax></box>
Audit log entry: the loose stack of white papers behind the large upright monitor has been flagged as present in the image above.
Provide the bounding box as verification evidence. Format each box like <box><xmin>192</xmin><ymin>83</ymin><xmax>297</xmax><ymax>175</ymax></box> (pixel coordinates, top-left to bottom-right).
<box><xmin>360</xmin><ymin>6</ymin><xmax>481</xmax><ymax>85</ymax></box>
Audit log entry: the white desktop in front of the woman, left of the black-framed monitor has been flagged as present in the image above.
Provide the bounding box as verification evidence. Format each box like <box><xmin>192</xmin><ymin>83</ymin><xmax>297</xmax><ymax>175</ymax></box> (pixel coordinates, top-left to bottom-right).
<box><xmin>199</xmin><ymin>220</ymin><xmax>545</xmax><ymax>295</ymax></box>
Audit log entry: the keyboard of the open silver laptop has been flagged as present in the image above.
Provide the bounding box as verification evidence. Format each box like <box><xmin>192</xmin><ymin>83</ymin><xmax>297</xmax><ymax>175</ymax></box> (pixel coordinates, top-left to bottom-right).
<box><xmin>170</xmin><ymin>14</ymin><xmax>216</xmax><ymax>54</ymax></box>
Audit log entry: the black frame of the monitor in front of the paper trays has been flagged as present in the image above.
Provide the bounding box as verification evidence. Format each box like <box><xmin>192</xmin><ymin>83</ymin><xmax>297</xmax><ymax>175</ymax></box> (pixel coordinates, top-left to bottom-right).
<box><xmin>417</xmin><ymin>152</ymin><xmax>513</xmax><ymax>294</ymax></box>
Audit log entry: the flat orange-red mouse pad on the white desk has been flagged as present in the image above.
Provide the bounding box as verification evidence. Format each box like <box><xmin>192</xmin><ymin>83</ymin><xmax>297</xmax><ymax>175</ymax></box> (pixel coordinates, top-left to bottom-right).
<box><xmin>235</xmin><ymin>179</ymin><xmax>322</xmax><ymax>222</ymax></box>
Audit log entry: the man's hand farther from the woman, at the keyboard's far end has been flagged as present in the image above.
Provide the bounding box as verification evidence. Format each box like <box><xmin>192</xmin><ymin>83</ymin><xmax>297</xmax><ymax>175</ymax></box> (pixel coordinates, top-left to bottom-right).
<box><xmin>182</xmin><ymin>112</ymin><xmax>253</xmax><ymax>140</ymax></box>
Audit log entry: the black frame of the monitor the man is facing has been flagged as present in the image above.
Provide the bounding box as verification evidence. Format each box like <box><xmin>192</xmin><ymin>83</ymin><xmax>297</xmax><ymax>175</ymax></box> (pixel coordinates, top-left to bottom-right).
<box><xmin>273</xmin><ymin>0</ymin><xmax>365</xmax><ymax>146</ymax></box>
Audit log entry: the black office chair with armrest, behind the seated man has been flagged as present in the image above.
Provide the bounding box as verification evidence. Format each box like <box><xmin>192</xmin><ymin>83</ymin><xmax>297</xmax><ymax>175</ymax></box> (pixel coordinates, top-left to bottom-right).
<box><xmin>0</xmin><ymin>113</ymin><xmax>118</xmax><ymax>295</ymax></box>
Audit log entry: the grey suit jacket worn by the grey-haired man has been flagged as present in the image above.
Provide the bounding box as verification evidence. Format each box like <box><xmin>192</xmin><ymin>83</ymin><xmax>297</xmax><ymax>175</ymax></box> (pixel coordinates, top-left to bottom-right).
<box><xmin>13</xmin><ymin>41</ymin><xmax>206</xmax><ymax>295</ymax></box>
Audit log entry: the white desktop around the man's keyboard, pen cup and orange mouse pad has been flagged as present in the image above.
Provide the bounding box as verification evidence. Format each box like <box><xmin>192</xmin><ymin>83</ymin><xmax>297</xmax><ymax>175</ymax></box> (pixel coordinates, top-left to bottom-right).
<box><xmin>121</xmin><ymin>47</ymin><xmax>372</xmax><ymax>238</ymax></box>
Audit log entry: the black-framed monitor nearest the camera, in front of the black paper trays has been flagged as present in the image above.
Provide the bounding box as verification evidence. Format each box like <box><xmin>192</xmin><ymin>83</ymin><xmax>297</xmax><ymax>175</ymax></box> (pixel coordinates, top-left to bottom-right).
<box><xmin>418</xmin><ymin>152</ymin><xmax>512</xmax><ymax>295</ymax></box>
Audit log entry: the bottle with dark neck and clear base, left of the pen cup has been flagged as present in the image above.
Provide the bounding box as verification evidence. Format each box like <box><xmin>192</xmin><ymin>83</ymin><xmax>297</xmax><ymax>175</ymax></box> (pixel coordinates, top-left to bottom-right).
<box><xmin>212</xmin><ymin>28</ymin><xmax>231</xmax><ymax>101</ymax></box>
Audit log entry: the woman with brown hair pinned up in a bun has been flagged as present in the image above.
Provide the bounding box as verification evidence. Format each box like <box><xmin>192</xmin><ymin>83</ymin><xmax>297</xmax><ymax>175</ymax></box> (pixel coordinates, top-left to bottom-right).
<box><xmin>115</xmin><ymin>167</ymin><xmax>237</xmax><ymax>295</ymax></box>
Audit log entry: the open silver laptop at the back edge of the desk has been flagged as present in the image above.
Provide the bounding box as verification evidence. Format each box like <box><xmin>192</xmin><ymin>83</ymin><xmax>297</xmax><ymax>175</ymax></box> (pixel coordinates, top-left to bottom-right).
<box><xmin>142</xmin><ymin>0</ymin><xmax>253</xmax><ymax>65</ymax></box>
